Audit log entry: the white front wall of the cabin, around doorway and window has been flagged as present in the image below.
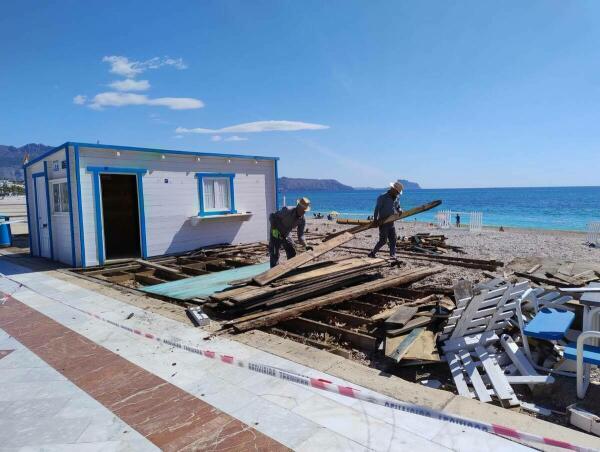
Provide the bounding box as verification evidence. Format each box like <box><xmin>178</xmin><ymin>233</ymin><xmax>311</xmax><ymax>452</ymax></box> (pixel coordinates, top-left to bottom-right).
<box><xmin>76</xmin><ymin>147</ymin><xmax>276</xmax><ymax>266</ymax></box>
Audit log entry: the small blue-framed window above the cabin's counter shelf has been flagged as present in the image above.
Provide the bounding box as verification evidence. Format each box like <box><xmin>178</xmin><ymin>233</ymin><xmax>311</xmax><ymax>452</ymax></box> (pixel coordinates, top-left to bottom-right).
<box><xmin>196</xmin><ymin>173</ymin><xmax>237</xmax><ymax>217</ymax></box>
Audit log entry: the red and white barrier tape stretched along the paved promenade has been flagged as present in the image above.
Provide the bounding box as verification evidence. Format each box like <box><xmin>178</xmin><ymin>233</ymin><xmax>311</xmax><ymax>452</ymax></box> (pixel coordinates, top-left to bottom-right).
<box><xmin>0</xmin><ymin>286</ymin><xmax>598</xmax><ymax>452</ymax></box>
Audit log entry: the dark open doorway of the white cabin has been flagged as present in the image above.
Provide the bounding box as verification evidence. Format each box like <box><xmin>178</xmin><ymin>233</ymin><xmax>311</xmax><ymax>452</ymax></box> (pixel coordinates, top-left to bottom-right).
<box><xmin>100</xmin><ymin>174</ymin><xmax>141</xmax><ymax>259</ymax></box>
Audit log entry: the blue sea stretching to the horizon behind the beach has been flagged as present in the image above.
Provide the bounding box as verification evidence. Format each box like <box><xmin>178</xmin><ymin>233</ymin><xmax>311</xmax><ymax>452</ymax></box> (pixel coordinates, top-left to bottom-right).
<box><xmin>279</xmin><ymin>187</ymin><xmax>600</xmax><ymax>231</ymax></box>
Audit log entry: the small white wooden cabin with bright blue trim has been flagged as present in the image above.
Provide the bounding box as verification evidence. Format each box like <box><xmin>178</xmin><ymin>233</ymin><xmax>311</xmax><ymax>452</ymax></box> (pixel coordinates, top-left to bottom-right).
<box><xmin>24</xmin><ymin>142</ymin><xmax>278</xmax><ymax>267</ymax></box>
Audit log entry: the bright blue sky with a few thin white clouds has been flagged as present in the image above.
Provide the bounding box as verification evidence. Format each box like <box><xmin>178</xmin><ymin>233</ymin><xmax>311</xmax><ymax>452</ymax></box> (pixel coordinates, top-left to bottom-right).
<box><xmin>0</xmin><ymin>0</ymin><xmax>600</xmax><ymax>188</ymax></box>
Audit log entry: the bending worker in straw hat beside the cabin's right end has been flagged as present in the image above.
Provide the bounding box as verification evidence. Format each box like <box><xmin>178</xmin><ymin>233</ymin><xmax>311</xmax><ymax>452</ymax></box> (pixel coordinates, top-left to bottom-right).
<box><xmin>269</xmin><ymin>198</ymin><xmax>310</xmax><ymax>267</ymax></box>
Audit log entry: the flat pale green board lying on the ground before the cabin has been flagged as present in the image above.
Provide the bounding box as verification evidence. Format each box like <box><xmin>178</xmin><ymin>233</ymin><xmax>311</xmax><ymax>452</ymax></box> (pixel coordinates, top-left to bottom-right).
<box><xmin>141</xmin><ymin>262</ymin><xmax>269</xmax><ymax>300</ymax></box>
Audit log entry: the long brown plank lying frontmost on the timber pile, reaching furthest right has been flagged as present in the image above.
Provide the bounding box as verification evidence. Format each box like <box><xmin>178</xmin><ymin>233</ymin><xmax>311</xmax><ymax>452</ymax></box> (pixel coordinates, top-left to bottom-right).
<box><xmin>231</xmin><ymin>266</ymin><xmax>445</xmax><ymax>332</ymax></box>
